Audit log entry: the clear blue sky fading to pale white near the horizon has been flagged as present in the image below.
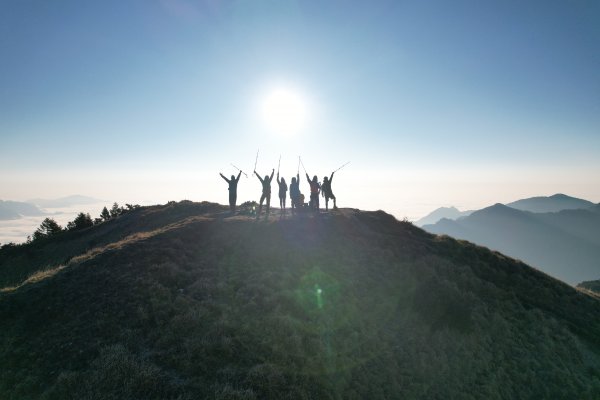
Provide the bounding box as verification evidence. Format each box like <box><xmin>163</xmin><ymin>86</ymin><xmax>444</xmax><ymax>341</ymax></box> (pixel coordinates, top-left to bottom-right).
<box><xmin>0</xmin><ymin>0</ymin><xmax>600</xmax><ymax>219</ymax></box>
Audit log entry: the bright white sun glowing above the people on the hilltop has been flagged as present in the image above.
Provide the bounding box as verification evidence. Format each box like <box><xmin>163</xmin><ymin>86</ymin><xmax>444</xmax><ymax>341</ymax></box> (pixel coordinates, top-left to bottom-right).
<box><xmin>260</xmin><ymin>87</ymin><xmax>308</xmax><ymax>135</ymax></box>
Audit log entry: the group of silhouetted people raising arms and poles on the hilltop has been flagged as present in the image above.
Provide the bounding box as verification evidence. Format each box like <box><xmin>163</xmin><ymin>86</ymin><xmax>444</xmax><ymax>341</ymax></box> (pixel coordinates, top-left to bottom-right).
<box><xmin>219</xmin><ymin>162</ymin><xmax>337</xmax><ymax>219</ymax></box>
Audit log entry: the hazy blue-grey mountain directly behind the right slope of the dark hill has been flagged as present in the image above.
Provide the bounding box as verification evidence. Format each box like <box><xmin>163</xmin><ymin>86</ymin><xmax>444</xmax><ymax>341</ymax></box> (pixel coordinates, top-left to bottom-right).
<box><xmin>423</xmin><ymin>204</ymin><xmax>600</xmax><ymax>285</ymax></box>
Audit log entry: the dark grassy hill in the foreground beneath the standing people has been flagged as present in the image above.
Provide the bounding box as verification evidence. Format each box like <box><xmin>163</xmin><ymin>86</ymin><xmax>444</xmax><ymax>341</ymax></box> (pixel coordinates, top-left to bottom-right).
<box><xmin>0</xmin><ymin>202</ymin><xmax>600</xmax><ymax>399</ymax></box>
